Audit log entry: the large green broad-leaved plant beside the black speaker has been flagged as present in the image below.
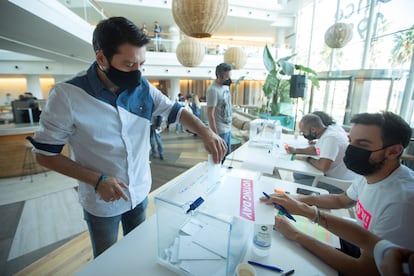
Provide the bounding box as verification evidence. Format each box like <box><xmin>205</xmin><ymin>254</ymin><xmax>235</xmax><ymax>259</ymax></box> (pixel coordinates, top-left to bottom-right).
<box><xmin>263</xmin><ymin>45</ymin><xmax>319</xmax><ymax>115</ymax></box>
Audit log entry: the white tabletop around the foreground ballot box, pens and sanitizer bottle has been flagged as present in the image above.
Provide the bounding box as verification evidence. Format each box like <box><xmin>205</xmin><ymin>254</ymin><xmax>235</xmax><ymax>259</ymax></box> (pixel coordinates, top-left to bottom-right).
<box><xmin>77</xmin><ymin>168</ymin><xmax>337</xmax><ymax>276</ymax></box>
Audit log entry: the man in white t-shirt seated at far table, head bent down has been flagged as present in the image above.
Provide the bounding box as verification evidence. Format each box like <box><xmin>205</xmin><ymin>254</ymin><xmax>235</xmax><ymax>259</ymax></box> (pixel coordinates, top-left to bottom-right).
<box><xmin>286</xmin><ymin>114</ymin><xmax>356</xmax><ymax>192</ymax></box>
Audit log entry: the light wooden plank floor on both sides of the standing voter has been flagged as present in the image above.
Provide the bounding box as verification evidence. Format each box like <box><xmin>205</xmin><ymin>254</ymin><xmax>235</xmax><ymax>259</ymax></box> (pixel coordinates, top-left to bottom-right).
<box><xmin>8</xmin><ymin>132</ymin><xmax>207</xmax><ymax>275</ymax></box>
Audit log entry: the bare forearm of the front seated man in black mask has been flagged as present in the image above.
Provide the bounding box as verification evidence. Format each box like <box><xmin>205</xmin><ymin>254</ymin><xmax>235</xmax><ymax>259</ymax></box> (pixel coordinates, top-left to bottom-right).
<box><xmin>296</xmin><ymin>194</ymin><xmax>352</xmax><ymax>209</ymax></box>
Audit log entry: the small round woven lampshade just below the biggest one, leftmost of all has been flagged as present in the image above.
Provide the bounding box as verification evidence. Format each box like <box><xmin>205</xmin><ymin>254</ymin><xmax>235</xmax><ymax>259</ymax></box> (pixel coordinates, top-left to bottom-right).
<box><xmin>175</xmin><ymin>37</ymin><xmax>205</xmax><ymax>67</ymax></box>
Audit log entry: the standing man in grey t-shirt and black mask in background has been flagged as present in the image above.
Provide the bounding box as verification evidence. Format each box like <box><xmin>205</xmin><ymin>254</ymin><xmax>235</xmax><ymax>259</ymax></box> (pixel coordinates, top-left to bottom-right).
<box><xmin>206</xmin><ymin>63</ymin><xmax>232</xmax><ymax>158</ymax></box>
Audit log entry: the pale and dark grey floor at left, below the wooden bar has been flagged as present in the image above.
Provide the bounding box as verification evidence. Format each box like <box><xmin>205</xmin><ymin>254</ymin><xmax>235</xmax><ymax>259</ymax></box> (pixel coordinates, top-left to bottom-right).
<box><xmin>0</xmin><ymin>172</ymin><xmax>82</xmax><ymax>275</ymax></box>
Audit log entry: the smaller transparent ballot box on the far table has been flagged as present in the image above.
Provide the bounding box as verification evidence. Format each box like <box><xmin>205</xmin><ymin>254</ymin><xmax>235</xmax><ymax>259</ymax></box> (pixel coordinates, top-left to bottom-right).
<box><xmin>249</xmin><ymin>119</ymin><xmax>282</xmax><ymax>149</ymax></box>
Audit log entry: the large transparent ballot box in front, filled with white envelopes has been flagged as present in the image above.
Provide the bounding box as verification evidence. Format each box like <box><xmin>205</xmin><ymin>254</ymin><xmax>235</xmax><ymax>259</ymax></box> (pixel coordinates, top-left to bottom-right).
<box><xmin>154</xmin><ymin>162</ymin><xmax>252</xmax><ymax>276</ymax></box>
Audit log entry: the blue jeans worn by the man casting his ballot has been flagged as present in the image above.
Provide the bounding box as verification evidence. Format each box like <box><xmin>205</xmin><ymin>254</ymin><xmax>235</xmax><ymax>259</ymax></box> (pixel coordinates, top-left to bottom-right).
<box><xmin>83</xmin><ymin>198</ymin><xmax>148</xmax><ymax>258</ymax></box>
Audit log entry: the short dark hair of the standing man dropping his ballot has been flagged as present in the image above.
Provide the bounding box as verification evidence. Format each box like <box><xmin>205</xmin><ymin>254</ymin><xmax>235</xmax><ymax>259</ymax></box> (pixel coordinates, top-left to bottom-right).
<box><xmin>92</xmin><ymin>17</ymin><xmax>150</xmax><ymax>61</ymax></box>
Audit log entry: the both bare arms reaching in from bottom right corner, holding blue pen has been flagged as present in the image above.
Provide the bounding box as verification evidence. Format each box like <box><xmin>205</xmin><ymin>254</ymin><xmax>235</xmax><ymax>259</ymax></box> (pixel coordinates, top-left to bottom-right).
<box><xmin>261</xmin><ymin>194</ymin><xmax>414</xmax><ymax>276</ymax></box>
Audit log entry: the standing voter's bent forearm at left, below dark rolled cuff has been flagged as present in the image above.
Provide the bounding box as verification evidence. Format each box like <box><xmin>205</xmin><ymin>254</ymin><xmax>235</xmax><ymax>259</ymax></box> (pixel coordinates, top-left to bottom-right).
<box><xmin>35</xmin><ymin>153</ymin><xmax>101</xmax><ymax>186</ymax></box>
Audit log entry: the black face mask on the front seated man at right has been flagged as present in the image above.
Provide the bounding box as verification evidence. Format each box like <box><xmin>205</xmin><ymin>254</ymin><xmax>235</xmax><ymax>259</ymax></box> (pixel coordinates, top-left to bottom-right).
<box><xmin>344</xmin><ymin>145</ymin><xmax>389</xmax><ymax>175</ymax></box>
